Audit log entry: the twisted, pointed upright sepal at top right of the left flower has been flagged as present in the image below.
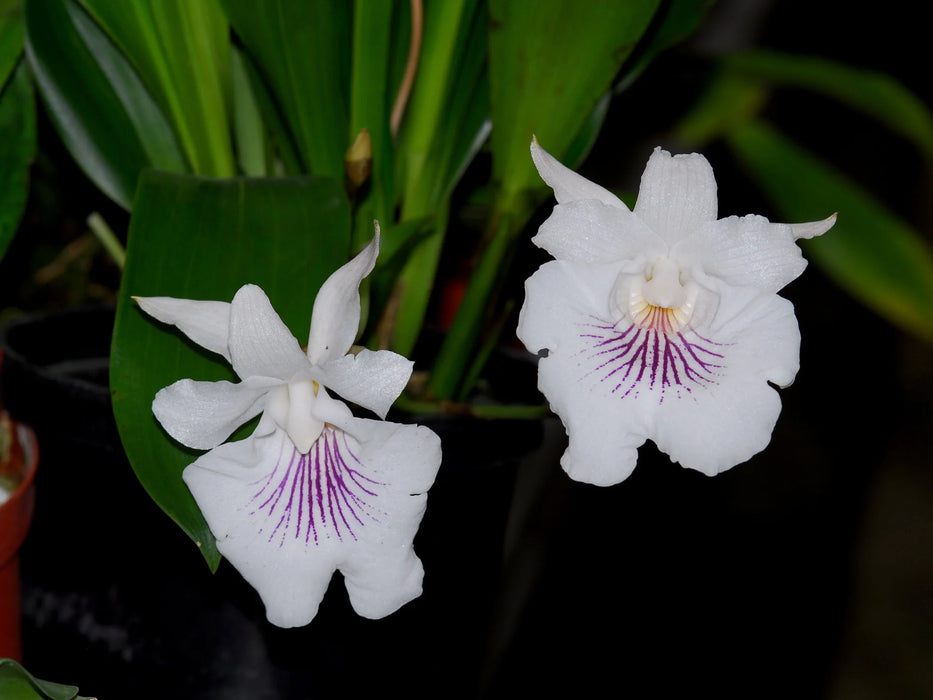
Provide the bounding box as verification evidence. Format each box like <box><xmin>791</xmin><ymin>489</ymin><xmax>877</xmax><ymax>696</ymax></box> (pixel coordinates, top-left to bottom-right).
<box><xmin>308</xmin><ymin>227</ymin><xmax>379</xmax><ymax>365</ymax></box>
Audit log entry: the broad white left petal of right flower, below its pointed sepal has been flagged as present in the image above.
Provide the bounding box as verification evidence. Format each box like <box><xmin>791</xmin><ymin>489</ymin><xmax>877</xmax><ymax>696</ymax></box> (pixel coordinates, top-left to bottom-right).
<box><xmin>532</xmin><ymin>199</ymin><xmax>667</xmax><ymax>263</ymax></box>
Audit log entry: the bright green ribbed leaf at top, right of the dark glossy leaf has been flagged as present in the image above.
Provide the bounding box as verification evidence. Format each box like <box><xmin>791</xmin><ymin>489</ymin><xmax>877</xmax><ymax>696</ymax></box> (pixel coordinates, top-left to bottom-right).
<box><xmin>83</xmin><ymin>0</ymin><xmax>236</xmax><ymax>177</ymax></box>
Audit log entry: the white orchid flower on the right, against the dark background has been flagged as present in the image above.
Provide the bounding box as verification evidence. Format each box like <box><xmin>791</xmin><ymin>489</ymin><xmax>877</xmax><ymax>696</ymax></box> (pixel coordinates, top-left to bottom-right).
<box><xmin>518</xmin><ymin>141</ymin><xmax>836</xmax><ymax>485</ymax></box>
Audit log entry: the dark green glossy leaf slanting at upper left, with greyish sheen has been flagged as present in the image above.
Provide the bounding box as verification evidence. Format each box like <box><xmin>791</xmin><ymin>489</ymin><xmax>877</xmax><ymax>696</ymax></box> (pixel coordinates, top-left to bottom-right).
<box><xmin>26</xmin><ymin>0</ymin><xmax>158</xmax><ymax>209</ymax></box>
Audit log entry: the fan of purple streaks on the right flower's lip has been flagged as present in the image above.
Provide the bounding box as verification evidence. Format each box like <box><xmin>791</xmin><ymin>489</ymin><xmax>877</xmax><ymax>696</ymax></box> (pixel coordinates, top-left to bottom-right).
<box><xmin>580</xmin><ymin>318</ymin><xmax>723</xmax><ymax>403</ymax></box>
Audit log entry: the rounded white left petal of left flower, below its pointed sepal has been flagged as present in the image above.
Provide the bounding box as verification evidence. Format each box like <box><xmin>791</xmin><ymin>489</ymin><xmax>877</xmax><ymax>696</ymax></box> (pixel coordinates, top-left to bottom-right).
<box><xmin>152</xmin><ymin>377</ymin><xmax>278</xmax><ymax>450</ymax></box>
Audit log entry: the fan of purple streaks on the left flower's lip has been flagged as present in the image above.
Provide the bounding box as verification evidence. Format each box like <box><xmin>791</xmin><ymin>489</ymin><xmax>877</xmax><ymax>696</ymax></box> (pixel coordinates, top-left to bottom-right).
<box><xmin>248</xmin><ymin>425</ymin><xmax>385</xmax><ymax>547</ymax></box>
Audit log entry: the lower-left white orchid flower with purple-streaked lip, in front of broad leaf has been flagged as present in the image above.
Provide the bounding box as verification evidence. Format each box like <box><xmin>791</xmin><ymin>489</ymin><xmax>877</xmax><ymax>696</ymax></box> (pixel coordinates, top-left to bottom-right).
<box><xmin>137</xmin><ymin>225</ymin><xmax>441</xmax><ymax>627</ymax></box>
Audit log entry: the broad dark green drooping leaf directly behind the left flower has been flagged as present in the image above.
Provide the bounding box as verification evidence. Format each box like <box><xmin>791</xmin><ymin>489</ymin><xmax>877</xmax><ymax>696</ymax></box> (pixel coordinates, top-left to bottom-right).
<box><xmin>111</xmin><ymin>171</ymin><xmax>351</xmax><ymax>568</ymax></box>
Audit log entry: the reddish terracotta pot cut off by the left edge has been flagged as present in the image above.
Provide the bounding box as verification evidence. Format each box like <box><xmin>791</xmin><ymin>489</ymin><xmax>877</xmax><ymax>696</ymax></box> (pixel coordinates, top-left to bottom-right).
<box><xmin>0</xmin><ymin>411</ymin><xmax>39</xmax><ymax>661</ymax></box>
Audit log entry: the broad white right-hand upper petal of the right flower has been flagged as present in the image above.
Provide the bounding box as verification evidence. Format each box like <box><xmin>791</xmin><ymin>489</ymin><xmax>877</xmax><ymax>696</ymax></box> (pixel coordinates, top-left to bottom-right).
<box><xmin>675</xmin><ymin>215</ymin><xmax>807</xmax><ymax>292</ymax></box>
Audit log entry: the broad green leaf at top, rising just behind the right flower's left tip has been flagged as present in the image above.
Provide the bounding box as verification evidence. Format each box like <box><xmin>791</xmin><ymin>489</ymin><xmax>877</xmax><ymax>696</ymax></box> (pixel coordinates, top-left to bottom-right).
<box><xmin>489</xmin><ymin>0</ymin><xmax>659</xmax><ymax>202</ymax></box>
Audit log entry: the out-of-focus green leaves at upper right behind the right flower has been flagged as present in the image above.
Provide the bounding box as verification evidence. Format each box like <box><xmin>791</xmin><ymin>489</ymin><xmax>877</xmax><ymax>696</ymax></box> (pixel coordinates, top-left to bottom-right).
<box><xmin>676</xmin><ymin>51</ymin><xmax>933</xmax><ymax>341</ymax></box>
